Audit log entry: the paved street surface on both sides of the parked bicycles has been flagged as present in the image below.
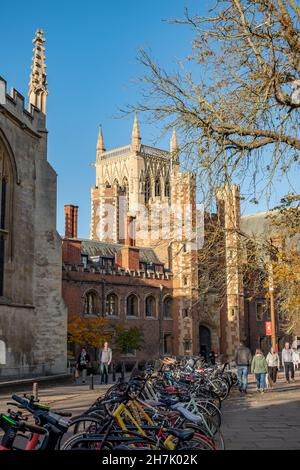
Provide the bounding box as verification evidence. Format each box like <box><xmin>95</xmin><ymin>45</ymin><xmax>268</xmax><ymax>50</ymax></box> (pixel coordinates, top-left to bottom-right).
<box><xmin>0</xmin><ymin>373</ymin><xmax>300</xmax><ymax>450</ymax></box>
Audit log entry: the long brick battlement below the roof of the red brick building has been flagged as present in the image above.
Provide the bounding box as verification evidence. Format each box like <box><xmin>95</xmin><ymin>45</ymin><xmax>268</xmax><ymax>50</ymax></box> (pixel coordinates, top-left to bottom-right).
<box><xmin>62</xmin><ymin>262</ymin><xmax>173</xmax><ymax>281</ymax></box>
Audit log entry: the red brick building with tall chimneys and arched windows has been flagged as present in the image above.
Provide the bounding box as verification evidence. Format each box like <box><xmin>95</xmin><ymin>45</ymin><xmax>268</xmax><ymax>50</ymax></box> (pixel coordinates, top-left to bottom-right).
<box><xmin>62</xmin><ymin>206</ymin><xmax>178</xmax><ymax>360</ymax></box>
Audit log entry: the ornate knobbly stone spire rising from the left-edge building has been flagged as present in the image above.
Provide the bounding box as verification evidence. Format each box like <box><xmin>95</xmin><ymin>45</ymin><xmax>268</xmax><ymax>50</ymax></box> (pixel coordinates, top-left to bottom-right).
<box><xmin>28</xmin><ymin>29</ymin><xmax>48</xmax><ymax>114</ymax></box>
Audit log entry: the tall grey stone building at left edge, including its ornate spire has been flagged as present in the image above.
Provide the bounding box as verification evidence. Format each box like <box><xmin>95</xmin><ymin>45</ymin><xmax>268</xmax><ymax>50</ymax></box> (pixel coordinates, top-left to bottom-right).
<box><xmin>0</xmin><ymin>30</ymin><xmax>67</xmax><ymax>377</ymax></box>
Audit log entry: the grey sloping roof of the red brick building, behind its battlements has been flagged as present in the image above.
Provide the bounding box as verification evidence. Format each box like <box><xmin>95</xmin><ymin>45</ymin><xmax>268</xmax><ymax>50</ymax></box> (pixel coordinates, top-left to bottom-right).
<box><xmin>81</xmin><ymin>240</ymin><xmax>163</xmax><ymax>264</ymax></box>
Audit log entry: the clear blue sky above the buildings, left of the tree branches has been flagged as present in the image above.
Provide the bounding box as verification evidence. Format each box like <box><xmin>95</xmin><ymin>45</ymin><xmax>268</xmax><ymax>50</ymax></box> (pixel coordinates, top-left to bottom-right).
<box><xmin>0</xmin><ymin>0</ymin><xmax>298</xmax><ymax>237</ymax></box>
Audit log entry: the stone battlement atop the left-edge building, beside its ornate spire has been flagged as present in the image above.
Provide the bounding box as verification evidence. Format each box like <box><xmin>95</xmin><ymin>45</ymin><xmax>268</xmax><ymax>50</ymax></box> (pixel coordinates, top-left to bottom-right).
<box><xmin>0</xmin><ymin>77</ymin><xmax>46</xmax><ymax>133</ymax></box>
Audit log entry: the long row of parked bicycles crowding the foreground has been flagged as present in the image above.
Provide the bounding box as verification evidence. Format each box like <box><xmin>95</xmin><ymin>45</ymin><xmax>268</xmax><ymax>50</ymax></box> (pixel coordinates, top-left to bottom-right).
<box><xmin>0</xmin><ymin>358</ymin><xmax>237</xmax><ymax>451</ymax></box>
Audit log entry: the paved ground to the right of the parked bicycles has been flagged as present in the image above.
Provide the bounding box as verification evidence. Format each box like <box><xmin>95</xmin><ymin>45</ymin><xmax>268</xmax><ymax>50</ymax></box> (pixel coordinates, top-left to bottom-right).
<box><xmin>221</xmin><ymin>372</ymin><xmax>300</xmax><ymax>450</ymax></box>
